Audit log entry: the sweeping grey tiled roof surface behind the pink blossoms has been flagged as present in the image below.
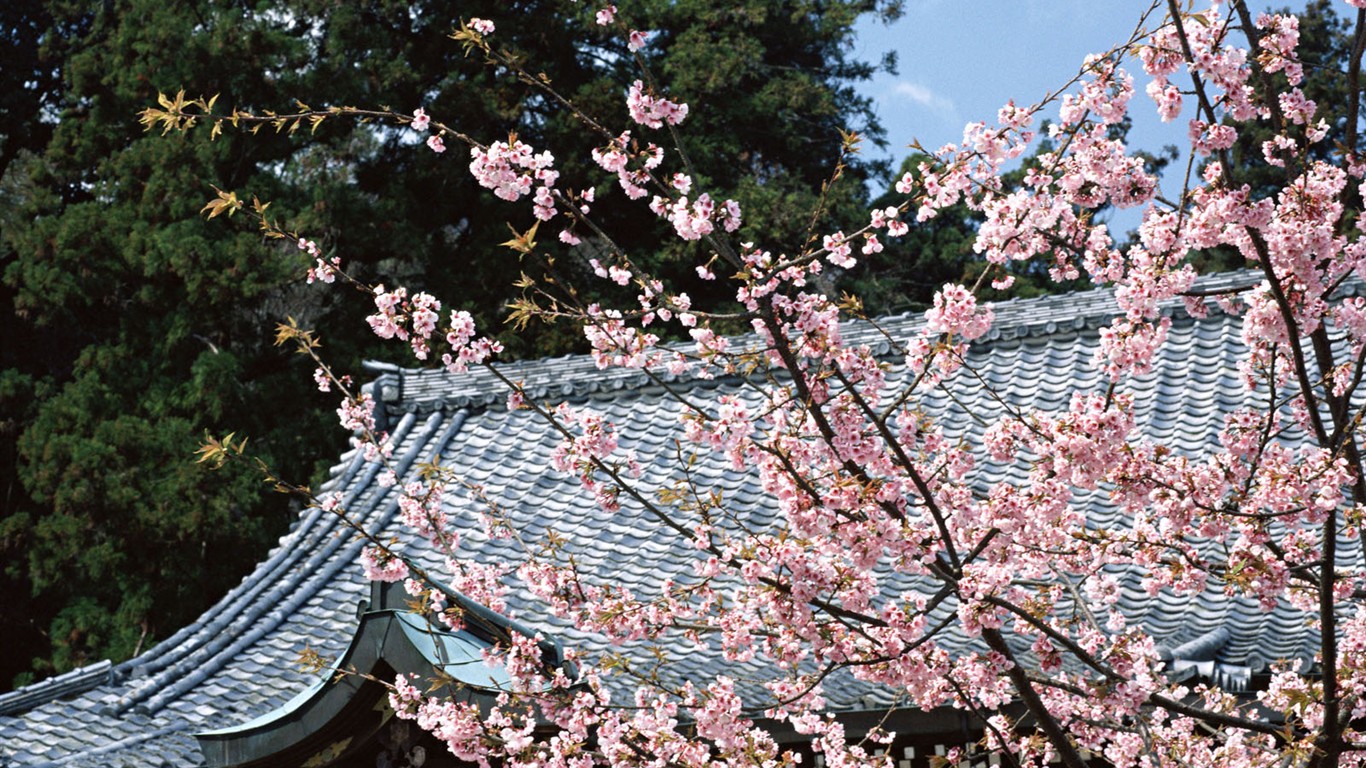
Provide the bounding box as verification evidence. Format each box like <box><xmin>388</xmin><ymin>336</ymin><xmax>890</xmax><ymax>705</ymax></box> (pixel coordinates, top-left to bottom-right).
<box><xmin>0</xmin><ymin>273</ymin><xmax>1333</xmax><ymax>768</ymax></box>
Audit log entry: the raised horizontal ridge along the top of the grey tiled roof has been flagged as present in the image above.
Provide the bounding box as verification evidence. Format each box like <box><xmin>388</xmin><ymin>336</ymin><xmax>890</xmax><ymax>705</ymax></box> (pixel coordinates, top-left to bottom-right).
<box><xmin>365</xmin><ymin>269</ymin><xmax>1267</xmax><ymax>413</ymax></box>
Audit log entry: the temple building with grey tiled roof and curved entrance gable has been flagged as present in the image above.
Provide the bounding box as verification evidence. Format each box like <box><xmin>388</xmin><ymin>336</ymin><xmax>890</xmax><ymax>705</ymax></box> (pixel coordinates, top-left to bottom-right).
<box><xmin>0</xmin><ymin>273</ymin><xmax>1327</xmax><ymax>768</ymax></box>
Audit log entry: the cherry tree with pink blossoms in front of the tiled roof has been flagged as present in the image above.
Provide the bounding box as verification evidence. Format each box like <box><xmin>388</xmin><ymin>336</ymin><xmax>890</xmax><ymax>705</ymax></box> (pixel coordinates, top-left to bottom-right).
<box><xmin>152</xmin><ymin>0</ymin><xmax>1366</xmax><ymax>768</ymax></box>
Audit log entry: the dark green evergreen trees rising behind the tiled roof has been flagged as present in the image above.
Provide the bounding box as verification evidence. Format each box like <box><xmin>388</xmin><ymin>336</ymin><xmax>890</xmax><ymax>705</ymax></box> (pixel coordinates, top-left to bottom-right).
<box><xmin>0</xmin><ymin>0</ymin><xmax>1350</xmax><ymax>690</ymax></box>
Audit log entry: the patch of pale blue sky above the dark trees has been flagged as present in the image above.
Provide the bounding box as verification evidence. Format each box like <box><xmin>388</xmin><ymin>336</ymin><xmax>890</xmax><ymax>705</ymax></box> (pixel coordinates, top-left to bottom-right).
<box><xmin>854</xmin><ymin>0</ymin><xmax>1284</xmax><ymax>224</ymax></box>
